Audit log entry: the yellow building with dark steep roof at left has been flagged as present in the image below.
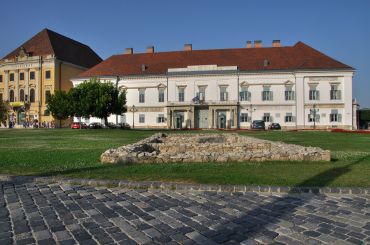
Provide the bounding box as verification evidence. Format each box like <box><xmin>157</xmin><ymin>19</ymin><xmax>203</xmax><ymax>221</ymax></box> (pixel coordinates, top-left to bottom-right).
<box><xmin>0</xmin><ymin>29</ymin><xmax>101</xmax><ymax>127</ymax></box>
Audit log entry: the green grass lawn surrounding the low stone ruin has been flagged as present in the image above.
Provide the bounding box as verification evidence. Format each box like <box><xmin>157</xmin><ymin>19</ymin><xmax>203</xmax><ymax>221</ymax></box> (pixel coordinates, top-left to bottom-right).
<box><xmin>0</xmin><ymin>129</ymin><xmax>370</xmax><ymax>187</ymax></box>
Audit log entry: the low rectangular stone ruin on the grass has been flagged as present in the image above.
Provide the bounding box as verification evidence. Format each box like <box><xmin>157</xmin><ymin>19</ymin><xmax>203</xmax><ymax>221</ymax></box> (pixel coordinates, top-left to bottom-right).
<box><xmin>100</xmin><ymin>133</ymin><xmax>330</xmax><ymax>164</ymax></box>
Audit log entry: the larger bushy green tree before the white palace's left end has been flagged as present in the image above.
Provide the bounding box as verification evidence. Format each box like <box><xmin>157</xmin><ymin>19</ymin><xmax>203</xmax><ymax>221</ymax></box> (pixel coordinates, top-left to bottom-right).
<box><xmin>71</xmin><ymin>78</ymin><xmax>126</xmax><ymax>125</ymax></box>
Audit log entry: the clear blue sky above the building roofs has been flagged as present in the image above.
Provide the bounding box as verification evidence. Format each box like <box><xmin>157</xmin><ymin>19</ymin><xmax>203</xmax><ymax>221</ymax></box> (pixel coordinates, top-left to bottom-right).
<box><xmin>0</xmin><ymin>0</ymin><xmax>370</xmax><ymax>107</ymax></box>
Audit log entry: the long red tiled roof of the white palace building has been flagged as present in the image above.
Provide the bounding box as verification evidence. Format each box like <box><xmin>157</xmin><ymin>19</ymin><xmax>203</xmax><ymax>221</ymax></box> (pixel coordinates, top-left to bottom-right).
<box><xmin>79</xmin><ymin>42</ymin><xmax>353</xmax><ymax>78</ymax></box>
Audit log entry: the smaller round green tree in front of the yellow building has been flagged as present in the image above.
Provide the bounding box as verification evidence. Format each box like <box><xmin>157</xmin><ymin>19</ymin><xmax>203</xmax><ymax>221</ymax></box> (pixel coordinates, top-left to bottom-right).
<box><xmin>47</xmin><ymin>91</ymin><xmax>73</xmax><ymax>126</ymax></box>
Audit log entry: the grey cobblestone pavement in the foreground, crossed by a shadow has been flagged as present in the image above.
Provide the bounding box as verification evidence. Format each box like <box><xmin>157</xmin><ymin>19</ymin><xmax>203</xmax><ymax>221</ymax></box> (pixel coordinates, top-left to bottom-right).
<box><xmin>0</xmin><ymin>179</ymin><xmax>370</xmax><ymax>245</ymax></box>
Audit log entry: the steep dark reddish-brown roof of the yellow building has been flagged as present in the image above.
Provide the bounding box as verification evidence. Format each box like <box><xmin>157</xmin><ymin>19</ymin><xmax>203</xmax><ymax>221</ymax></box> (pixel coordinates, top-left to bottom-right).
<box><xmin>2</xmin><ymin>29</ymin><xmax>102</xmax><ymax>68</ymax></box>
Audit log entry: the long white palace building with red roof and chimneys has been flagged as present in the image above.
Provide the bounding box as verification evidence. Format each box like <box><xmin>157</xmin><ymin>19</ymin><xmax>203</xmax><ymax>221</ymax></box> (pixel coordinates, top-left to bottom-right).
<box><xmin>72</xmin><ymin>40</ymin><xmax>356</xmax><ymax>129</ymax></box>
